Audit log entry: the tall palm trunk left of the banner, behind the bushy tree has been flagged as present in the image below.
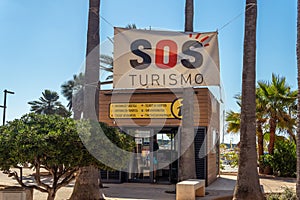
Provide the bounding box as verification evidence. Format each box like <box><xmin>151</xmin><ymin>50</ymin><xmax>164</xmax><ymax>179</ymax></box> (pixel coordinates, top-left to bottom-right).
<box><xmin>70</xmin><ymin>0</ymin><xmax>103</xmax><ymax>200</ymax></box>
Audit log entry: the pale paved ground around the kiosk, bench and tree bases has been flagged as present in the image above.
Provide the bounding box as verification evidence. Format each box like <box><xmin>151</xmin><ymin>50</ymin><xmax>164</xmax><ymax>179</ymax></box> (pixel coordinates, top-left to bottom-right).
<box><xmin>0</xmin><ymin>170</ymin><xmax>296</xmax><ymax>200</ymax></box>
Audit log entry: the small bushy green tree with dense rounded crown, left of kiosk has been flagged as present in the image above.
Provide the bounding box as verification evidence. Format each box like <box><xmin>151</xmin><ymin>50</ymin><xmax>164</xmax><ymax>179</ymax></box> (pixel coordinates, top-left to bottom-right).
<box><xmin>0</xmin><ymin>113</ymin><xmax>134</xmax><ymax>200</ymax></box>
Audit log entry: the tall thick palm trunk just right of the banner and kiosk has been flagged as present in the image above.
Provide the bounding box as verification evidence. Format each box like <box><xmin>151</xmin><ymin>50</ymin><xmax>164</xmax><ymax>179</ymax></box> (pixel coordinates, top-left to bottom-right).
<box><xmin>233</xmin><ymin>0</ymin><xmax>263</xmax><ymax>200</ymax></box>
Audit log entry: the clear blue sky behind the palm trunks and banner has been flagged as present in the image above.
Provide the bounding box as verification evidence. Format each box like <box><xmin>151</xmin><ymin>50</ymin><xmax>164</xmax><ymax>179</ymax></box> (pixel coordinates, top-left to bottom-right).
<box><xmin>0</xmin><ymin>0</ymin><xmax>297</xmax><ymax>142</ymax></box>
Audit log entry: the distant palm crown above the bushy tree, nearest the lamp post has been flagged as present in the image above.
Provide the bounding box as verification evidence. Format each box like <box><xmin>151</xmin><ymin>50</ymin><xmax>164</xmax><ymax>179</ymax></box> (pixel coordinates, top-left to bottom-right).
<box><xmin>28</xmin><ymin>90</ymin><xmax>70</xmax><ymax>117</ymax></box>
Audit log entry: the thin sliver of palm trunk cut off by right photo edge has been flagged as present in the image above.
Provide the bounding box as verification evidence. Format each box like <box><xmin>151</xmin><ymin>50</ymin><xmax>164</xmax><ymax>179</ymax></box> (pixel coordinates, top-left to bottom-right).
<box><xmin>296</xmin><ymin>0</ymin><xmax>300</xmax><ymax>199</ymax></box>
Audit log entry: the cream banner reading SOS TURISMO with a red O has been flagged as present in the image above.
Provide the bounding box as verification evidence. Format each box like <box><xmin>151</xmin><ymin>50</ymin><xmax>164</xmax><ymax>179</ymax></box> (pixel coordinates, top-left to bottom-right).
<box><xmin>113</xmin><ymin>28</ymin><xmax>220</xmax><ymax>89</ymax></box>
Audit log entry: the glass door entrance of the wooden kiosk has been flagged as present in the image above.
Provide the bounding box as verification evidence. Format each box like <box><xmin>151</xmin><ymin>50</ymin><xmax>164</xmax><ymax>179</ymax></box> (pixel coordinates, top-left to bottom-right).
<box><xmin>127</xmin><ymin>128</ymin><xmax>178</xmax><ymax>183</ymax></box>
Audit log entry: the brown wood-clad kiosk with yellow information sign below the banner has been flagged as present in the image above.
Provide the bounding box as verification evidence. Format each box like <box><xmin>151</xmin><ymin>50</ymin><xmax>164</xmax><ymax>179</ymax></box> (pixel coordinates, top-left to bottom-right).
<box><xmin>99</xmin><ymin>88</ymin><xmax>220</xmax><ymax>184</ymax></box>
